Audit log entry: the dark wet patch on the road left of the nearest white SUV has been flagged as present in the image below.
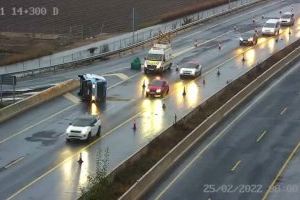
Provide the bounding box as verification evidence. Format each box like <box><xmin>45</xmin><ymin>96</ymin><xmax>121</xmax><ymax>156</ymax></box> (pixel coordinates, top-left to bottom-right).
<box><xmin>25</xmin><ymin>131</ymin><xmax>62</xmax><ymax>146</ymax></box>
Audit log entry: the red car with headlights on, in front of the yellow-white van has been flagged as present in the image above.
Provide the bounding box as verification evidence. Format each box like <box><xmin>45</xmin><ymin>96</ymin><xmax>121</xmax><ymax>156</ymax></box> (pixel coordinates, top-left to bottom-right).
<box><xmin>146</xmin><ymin>79</ymin><xmax>169</xmax><ymax>97</ymax></box>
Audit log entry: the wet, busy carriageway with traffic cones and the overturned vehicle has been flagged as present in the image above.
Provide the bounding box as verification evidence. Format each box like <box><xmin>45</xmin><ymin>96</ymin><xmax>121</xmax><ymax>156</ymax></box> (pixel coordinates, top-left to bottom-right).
<box><xmin>0</xmin><ymin>1</ymin><xmax>300</xmax><ymax>199</ymax></box>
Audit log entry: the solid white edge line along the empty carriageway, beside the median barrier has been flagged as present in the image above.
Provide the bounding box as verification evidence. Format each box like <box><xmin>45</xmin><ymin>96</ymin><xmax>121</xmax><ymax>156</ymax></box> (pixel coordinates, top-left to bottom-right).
<box><xmin>155</xmin><ymin>52</ymin><xmax>299</xmax><ymax>200</ymax></box>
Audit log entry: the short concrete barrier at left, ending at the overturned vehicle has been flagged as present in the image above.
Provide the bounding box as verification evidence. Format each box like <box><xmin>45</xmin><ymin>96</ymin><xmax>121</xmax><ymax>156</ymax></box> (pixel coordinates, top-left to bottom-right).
<box><xmin>0</xmin><ymin>80</ymin><xmax>79</xmax><ymax>123</ymax></box>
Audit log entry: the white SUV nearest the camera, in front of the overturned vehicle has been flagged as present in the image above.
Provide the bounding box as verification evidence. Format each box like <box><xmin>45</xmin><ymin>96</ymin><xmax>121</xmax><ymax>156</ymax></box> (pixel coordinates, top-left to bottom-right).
<box><xmin>66</xmin><ymin>116</ymin><xmax>101</xmax><ymax>142</ymax></box>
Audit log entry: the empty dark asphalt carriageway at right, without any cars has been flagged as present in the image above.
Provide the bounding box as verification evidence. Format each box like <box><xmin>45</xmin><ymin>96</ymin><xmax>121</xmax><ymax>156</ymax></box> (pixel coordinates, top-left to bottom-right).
<box><xmin>145</xmin><ymin>57</ymin><xmax>300</xmax><ymax>200</ymax></box>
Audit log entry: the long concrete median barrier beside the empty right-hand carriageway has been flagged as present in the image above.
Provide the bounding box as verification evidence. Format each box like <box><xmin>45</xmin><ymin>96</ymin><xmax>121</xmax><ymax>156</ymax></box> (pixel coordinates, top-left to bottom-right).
<box><xmin>120</xmin><ymin>41</ymin><xmax>300</xmax><ymax>200</ymax></box>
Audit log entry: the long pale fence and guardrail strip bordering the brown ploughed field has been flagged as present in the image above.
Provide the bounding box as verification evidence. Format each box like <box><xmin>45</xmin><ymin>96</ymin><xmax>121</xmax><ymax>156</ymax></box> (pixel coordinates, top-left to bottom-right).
<box><xmin>0</xmin><ymin>0</ymin><xmax>263</xmax><ymax>77</ymax></box>
